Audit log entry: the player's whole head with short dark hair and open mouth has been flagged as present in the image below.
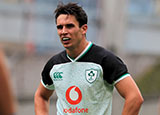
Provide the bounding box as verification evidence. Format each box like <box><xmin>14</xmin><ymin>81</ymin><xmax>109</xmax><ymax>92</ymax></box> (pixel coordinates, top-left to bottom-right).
<box><xmin>55</xmin><ymin>3</ymin><xmax>88</xmax><ymax>50</ymax></box>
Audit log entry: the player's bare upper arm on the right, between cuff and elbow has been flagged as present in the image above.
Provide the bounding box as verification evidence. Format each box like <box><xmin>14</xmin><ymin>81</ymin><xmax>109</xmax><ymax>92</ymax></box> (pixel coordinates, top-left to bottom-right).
<box><xmin>115</xmin><ymin>76</ymin><xmax>142</xmax><ymax>98</ymax></box>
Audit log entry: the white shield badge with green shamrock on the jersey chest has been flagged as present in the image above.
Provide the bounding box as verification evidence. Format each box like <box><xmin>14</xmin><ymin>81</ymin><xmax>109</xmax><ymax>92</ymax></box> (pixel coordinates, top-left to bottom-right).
<box><xmin>85</xmin><ymin>69</ymin><xmax>98</xmax><ymax>83</ymax></box>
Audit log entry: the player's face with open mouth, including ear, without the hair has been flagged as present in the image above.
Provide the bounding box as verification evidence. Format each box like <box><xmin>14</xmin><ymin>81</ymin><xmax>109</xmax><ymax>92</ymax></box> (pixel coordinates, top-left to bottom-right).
<box><xmin>57</xmin><ymin>14</ymin><xmax>87</xmax><ymax>49</ymax></box>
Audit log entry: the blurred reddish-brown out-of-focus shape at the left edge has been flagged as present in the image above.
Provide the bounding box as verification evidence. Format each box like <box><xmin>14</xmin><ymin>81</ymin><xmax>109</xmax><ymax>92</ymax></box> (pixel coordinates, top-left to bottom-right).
<box><xmin>0</xmin><ymin>49</ymin><xmax>15</xmax><ymax>115</ymax></box>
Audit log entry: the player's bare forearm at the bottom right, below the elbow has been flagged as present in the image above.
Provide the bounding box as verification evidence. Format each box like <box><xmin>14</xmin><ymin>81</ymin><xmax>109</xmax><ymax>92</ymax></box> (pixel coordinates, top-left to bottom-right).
<box><xmin>122</xmin><ymin>98</ymin><xmax>143</xmax><ymax>115</ymax></box>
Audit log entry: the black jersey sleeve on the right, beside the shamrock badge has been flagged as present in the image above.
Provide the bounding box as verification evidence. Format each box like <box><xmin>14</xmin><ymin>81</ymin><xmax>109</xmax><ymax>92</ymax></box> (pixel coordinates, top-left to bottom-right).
<box><xmin>102</xmin><ymin>52</ymin><xmax>128</xmax><ymax>84</ymax></box>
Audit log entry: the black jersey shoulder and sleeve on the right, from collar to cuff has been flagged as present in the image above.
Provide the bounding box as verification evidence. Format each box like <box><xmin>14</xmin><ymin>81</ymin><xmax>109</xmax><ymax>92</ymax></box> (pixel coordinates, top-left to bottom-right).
<box><xmin>93</xmin><ymin>45</ymin><xmax>128</xmax><ymax>84</ymax></box>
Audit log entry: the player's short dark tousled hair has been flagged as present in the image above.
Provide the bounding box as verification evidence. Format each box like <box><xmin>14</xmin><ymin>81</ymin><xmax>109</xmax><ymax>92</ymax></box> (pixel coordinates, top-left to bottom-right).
<box><xmin>54</xmin><ymin>2</ymin><xmax>88</xmax><ymax>27</ymax></box>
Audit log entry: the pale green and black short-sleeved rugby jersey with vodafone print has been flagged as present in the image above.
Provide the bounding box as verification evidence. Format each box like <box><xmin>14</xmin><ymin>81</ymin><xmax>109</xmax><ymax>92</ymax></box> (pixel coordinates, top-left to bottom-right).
<box><xmin>41</xmin><ymin>42</ymin><xmax>129</xmax><ymax>115</ymax></box>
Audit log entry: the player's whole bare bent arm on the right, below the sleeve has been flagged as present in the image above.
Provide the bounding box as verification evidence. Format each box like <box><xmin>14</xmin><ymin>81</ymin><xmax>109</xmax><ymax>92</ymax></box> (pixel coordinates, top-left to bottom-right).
<box><xmin>116</xmin><ymin>76</ymin><xmax>143</xmax><ymax>115</ymax></box>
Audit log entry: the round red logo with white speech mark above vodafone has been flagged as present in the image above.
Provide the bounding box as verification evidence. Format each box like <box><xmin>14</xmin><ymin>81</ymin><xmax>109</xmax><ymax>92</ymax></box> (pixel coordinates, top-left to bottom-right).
<box><xmin>66</xmin><ymin>86</ymin><xmax>82</xmax><ymax>105</ymax></box>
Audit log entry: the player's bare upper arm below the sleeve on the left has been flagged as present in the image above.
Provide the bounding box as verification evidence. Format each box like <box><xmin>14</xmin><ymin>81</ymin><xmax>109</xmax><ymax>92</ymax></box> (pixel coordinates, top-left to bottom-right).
<box><xmin>35</xmin><ymin>83</ymin><xmax>54</xmax><ymax>100</ymax></box>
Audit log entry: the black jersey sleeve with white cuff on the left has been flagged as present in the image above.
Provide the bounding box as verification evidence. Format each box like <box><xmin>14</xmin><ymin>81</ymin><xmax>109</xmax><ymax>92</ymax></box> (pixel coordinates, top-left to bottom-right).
<box><xmin>41</xmin><ymin>60</ymin><xmax>54</xmax><ymax>90</ymax></box>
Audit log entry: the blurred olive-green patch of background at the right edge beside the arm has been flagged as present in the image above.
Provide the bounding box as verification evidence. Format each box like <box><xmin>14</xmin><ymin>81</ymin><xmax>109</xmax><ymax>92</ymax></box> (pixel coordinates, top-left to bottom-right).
<box><xmin>136</xmin><ymin>61</ymin><xmax>160</xmax><ymax>97</ymax></box>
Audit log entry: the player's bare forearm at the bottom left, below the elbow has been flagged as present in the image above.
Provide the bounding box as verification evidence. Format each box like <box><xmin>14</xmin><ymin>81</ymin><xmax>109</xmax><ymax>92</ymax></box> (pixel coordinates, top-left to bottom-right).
<box><xmin>35</xmin><ymin>96</ymin><xmax>49</xmax><ymax>115</ymax></box>
